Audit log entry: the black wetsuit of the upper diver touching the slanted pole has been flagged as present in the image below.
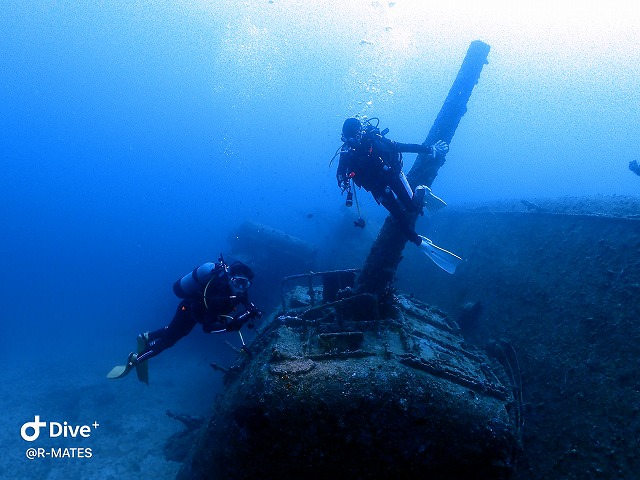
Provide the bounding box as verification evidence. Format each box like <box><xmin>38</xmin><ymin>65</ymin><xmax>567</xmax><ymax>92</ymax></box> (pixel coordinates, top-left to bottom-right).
<box><xmin>336</xmin><ymin>133</ymin><xmax>432</xmax><ymax>245</ymax></box>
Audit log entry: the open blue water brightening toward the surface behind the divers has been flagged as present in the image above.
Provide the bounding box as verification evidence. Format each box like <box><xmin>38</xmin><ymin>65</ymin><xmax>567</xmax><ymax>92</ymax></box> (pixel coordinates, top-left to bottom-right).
<box><xmin>0</xmin><ymin>0</ymin><xmax>640</xmax><ymax>478</ymax></box>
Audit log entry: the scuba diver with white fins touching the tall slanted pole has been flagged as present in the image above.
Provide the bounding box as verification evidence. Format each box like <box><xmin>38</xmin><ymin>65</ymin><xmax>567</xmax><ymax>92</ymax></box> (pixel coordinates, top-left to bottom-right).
<box><xmin>334</xmin><ymin>118</ymin><xmax>462</xmax><ymax>273</ymax></box>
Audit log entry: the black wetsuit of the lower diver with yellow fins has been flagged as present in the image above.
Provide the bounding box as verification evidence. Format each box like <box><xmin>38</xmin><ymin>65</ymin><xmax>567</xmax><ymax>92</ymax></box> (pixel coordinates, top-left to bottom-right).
<box><xmin>137</xmin><ymin>277</ymin><xmax>250</xmax><ymax>362</ymax></box>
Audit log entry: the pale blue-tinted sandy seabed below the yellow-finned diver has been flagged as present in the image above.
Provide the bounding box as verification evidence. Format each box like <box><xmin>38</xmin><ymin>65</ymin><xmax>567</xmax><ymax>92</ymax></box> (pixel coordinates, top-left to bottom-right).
<box><xmin>0</xmin><ymin>342</ymin><xmax>226</xmax><ymax>480</ymax></box>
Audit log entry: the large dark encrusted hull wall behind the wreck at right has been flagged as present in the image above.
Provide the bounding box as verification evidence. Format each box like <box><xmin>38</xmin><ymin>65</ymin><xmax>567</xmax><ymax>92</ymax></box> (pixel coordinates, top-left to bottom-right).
<box><xmin>398</xmin><ymin>196</ymin><xmax>640</xmax><ymax>480</ymax></box>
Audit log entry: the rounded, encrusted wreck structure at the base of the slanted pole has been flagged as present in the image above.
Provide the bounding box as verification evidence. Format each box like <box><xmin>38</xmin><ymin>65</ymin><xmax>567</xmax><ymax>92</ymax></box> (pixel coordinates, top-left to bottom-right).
<box><xmin>181</xmin><ymin>288</ymin><xmax>518</xmax><ymax>479</ymax></box>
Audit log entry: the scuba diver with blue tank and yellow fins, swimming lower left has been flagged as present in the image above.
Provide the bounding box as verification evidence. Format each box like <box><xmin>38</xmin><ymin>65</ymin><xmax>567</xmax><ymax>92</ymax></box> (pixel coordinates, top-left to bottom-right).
<box><xmin>107</xmin><ymin>255</ymin><xmax>262</xmax><ymax>383</ymax></box>
